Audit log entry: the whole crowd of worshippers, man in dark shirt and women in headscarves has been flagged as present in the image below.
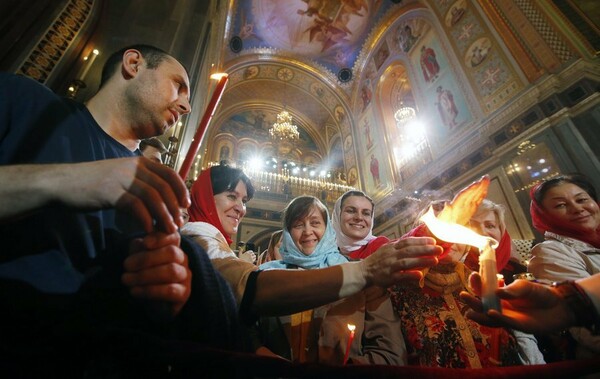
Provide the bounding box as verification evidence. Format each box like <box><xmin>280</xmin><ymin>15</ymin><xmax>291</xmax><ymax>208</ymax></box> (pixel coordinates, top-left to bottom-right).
<box><xmin>0</xmin><ymin>45</ymin><xmax>600</xmax><ymax>377</ymax></box>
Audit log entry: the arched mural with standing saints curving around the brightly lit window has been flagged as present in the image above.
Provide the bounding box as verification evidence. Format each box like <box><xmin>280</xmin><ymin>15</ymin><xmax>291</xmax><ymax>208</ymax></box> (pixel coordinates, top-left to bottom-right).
<box><xmin>355</xmin><ymin>12</ymin><xmax>473</xmax><ymax>199</ymax></box>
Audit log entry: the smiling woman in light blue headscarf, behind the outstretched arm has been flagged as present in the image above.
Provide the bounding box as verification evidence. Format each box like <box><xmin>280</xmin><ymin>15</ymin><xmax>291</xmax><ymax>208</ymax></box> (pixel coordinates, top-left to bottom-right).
<box><xmin>255</xmin><ymin>196</ymin><xmax>406</xmax><ymax>365</ymax></box>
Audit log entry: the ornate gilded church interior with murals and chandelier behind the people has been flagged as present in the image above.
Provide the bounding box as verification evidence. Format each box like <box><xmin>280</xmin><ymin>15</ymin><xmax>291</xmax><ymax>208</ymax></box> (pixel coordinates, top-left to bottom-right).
<box><xmin>0</xmin><ymin>0</ymin><xmax>600</xmax><ymax>249</ymax></box>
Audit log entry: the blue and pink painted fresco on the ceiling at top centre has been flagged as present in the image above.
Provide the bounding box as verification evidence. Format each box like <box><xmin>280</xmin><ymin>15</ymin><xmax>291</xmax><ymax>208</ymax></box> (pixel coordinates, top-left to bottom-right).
<box><xmin>233</xmin><ymin>0</ymin><xmax>394</xmax><ymax>79</ymax></box>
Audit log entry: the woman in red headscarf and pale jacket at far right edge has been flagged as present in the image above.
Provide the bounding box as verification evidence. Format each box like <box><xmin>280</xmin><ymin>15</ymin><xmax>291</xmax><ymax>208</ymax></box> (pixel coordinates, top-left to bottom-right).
<box><xmin>528</xmin><ymin>174</ymin><xmax>600</xmax><ymax>358</ymax></box>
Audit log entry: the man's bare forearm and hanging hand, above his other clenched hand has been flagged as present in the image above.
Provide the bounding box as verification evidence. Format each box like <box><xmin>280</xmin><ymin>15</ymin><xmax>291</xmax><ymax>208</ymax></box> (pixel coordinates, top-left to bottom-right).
<box><xmin>0</xmin><ymin>157</ymin><xmax>190</xmax><ymax>233</ymax></box>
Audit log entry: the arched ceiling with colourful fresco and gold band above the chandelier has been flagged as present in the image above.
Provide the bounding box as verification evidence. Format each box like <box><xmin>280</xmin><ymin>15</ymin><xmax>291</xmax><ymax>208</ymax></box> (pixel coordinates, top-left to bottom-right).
<box><xmin>209</xmin><ymin>0</ymin><xmax>415</xmax><ymax>161</ymax></box>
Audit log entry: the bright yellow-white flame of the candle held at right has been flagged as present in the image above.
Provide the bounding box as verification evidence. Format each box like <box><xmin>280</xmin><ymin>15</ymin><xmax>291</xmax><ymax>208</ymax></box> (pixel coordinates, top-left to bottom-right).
<box><xmin>420</xmin><ymin>207</ymin><xmax>498</xmax><ymax>250</ymax></box>
